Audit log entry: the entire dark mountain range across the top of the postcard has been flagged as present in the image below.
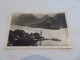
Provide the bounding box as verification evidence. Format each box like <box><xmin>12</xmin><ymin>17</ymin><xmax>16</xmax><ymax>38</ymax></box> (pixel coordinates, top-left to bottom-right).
<box><xmin>12</xmin><ymin>13</ymin><xmax>67</xmax><ymax>30</ymax></box>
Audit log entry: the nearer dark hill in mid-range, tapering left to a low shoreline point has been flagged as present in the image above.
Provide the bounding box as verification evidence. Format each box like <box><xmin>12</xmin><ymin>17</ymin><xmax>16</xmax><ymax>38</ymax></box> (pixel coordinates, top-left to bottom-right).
<box><xmin>30</xmin><ymin>17</ymin><xmax>59</xmax><ymax>29</ymax></box>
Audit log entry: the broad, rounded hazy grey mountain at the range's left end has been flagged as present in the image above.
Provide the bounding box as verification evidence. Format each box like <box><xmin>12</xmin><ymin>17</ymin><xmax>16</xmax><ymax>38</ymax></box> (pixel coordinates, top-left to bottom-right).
<box><xmin>11</xmin><ymin>14</ymin><xmax>39</xmax><ymax>26</ymax></box>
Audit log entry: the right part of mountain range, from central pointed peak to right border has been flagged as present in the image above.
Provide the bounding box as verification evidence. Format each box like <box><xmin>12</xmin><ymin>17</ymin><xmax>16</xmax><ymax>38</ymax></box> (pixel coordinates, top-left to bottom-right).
<box><xmin>30</xmin><ymin>13</ymin><xmax>67</xmax><ymax>30</ymax></box>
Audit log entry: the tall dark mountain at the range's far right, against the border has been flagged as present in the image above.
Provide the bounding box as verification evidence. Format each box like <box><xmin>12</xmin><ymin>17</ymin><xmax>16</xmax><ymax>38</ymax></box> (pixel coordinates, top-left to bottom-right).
<box><xmin>53</xmin><ymin>13</ymin><xmax>67</xmax><ymax>28</ymax></box>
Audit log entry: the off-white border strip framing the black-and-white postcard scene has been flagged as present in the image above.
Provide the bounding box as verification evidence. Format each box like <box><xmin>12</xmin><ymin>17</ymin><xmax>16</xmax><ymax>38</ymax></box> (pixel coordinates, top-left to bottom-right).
<box><xmin>4</xmin><ymin>11</ymin><xmax>72</xmax><ymax>49</ymax></box>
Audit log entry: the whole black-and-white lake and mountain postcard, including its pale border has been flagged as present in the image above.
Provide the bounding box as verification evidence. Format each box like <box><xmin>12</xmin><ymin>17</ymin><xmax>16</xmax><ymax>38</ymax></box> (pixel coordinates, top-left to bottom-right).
<box><xmin>6</xmin><ymin>12</ymin><xmax>72</xmax><ymax>48</ymax></box>
